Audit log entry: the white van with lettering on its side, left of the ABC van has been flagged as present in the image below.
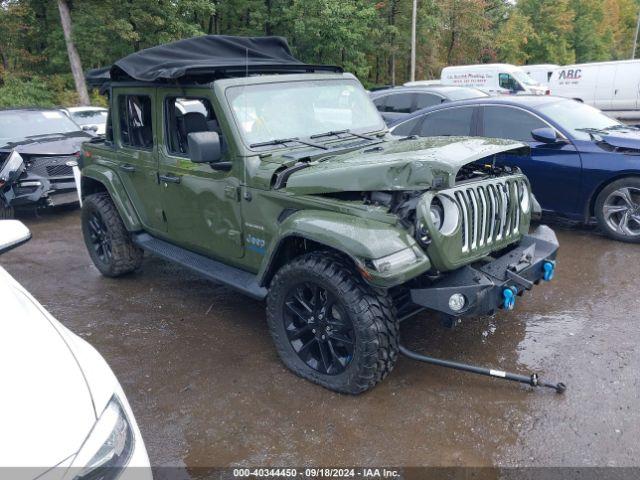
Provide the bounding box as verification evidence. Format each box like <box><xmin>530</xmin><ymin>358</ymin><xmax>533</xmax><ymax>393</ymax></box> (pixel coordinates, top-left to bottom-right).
<box><xmin>440</xmin><ymin>63</ymin><xmax>548</xmax><ymax>95</ymax></box>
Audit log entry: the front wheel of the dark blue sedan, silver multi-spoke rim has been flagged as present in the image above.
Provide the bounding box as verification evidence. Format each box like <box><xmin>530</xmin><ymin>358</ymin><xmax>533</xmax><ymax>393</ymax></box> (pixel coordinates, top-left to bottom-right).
<box><xmin>595</xmin><ymin>177</ymin><xmax>640</xmax><ymax>243</ymax></box>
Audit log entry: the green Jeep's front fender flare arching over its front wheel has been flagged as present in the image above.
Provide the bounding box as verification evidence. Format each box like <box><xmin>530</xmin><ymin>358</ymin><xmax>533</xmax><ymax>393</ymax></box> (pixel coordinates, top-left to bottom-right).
<box><xmin>258</xmin><ymin>210</ymin><xmax>431</xmax><ymax>287</ymax></box>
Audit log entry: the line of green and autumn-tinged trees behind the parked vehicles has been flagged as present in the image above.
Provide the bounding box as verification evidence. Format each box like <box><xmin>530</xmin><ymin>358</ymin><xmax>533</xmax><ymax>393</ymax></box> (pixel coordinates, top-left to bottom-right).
<box><xmin>0</xmin><ymin>0</ymin><xmax>640</xmax><ymax>106</ymax></box>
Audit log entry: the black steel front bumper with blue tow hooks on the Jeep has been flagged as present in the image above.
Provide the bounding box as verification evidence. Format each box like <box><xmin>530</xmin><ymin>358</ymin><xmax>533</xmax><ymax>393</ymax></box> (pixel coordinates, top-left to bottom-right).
<box><xmin>409</xmin><ymin>225</ymin><xmax>558</xmax><ymax>317</ymax></box>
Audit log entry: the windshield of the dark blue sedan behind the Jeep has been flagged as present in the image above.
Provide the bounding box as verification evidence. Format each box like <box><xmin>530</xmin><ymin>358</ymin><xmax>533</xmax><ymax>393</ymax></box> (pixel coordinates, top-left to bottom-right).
<box><xmin>538</xmin><ymin>100</ymin><xmax>631</xmax><ymax>140</ymax></box>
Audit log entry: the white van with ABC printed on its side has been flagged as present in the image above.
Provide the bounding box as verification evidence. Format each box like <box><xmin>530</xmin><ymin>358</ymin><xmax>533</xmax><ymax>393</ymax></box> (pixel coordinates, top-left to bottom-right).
<box><xmin>549</xmin><ymin>60</ymin><xmax>640</xmax><ymax>118</ymax></box>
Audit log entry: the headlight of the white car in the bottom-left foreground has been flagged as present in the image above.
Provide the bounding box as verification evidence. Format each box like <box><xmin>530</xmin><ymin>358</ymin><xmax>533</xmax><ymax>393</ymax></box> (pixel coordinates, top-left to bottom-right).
<box><xmin>73</xmin><ymin>395</ymin><xmax>134</xmax><ymax>480</ymax></box>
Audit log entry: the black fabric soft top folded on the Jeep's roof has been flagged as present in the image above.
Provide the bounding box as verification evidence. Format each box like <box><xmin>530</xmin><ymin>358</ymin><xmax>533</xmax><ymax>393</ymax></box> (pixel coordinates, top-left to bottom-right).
<box><xmin>86</xmin><ymin>35</ymin><xmax>342</xmax><ymax>86</ymax></box>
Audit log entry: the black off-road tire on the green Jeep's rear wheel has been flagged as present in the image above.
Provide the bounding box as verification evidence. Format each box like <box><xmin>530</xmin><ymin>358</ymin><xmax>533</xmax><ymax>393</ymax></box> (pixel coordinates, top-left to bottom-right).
<box><xmin>82</xmin><ymin>192</ymin><xmax>144</xmax><ymax>277</ymax></box>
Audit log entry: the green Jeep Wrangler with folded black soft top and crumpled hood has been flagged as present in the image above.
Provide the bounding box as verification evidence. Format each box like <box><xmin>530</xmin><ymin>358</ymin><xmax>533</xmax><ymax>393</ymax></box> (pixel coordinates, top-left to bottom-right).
<box><xmin>80</xmin><ymin>36</ymin><xmax>558</xmax><ymax>394</ymax></box>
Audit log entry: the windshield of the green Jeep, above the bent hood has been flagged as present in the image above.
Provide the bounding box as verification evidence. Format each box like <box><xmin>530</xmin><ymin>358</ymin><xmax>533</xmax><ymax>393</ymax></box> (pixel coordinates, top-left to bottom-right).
<box><xmin>227</xmin><ymin>79</ymin><xmax>385</xmax><ymax>145</ymax></box>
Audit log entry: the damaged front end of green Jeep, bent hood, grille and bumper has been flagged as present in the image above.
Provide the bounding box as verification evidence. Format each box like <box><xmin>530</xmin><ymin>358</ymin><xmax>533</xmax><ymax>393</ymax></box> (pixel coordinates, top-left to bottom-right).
<box><xmin>278</xmin><ymin>139</ymin><xmax>558</xmax><ymax>318</ymax></box>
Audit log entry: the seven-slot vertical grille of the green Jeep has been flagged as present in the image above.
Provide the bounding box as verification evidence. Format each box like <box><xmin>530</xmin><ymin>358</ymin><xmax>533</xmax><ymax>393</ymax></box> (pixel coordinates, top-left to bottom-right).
<box><xmin>453</xmin><ymin>178</ymin><xmax>525</xmax><ymax>253</ymax></box>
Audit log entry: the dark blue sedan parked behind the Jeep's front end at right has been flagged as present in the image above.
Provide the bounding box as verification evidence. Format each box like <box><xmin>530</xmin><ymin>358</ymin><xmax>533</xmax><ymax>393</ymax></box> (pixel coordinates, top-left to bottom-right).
<box><xmin>391</xmin><ymin>96</ymin><xmax>640</xmax><ymax>243</ymax></box>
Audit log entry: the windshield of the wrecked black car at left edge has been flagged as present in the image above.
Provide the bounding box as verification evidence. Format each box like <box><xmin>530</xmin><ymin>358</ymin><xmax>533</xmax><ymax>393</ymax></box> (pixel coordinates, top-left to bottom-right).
<box><xmin>0</xmin><ymin>110</ymin><xmax>80</xmax><ymax>144</ymax></box>
